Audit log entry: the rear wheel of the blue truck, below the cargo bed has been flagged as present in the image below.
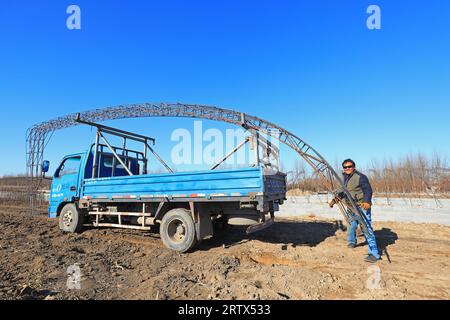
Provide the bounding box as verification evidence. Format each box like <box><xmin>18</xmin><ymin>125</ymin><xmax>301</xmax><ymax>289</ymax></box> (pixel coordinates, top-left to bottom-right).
<box><xmin>159</xmin><ymin>208</ymin><xmax>197</xmax><ymax>252</ymax></box>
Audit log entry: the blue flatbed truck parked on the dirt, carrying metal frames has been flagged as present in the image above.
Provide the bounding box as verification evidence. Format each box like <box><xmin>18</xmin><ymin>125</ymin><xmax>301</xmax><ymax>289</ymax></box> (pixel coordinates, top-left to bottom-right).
<box><xmin>43</xmin><ymin>118</ymin><xmax>286</xmax><ymax>252</ymax></box>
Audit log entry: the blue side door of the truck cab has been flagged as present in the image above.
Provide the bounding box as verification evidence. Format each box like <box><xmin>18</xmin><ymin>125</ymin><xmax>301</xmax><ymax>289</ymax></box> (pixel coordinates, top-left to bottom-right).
<box><xmin>50</xmin><ymin>156</ymin><xmax>81</xmax><ymax>206</ymax></box>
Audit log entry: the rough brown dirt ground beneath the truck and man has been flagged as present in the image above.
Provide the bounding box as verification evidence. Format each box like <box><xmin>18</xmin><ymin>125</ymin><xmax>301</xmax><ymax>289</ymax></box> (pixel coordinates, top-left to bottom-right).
<box><xmin>0</xmin><ymin>209</ymin><xmax>450</xmax><ymax>299</ymax></box>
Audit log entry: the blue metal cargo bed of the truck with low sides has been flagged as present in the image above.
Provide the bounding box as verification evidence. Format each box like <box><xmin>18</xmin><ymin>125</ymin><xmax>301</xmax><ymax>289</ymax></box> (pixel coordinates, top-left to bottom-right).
<box><xmin>81</xmin><ymin>167</ymin><xmax>286</xmax><ymax>201</ymax></box>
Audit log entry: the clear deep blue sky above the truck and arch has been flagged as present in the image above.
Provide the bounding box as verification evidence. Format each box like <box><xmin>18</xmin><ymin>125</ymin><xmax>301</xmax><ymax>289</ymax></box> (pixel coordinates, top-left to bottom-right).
<box><xmin>0</xmin><ymin>0</ymin><xmax>450</xmax><ymax>175</ymax></box>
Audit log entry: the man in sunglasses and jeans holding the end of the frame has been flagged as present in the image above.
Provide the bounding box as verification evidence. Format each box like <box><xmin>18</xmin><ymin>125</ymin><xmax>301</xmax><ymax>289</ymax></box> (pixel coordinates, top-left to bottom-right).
<box><xmin>330</xmin><ymin>159</ymin><xmax>380</xmax><ymax>263</ymax></box>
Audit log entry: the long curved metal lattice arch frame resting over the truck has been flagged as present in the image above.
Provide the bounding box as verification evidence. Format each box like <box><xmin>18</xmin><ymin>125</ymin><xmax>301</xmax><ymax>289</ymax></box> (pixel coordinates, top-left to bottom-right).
<box><xmin>26</xmin><ymin>103</ymin><xmax>368</xmax><ymax>233</ymax></box>
